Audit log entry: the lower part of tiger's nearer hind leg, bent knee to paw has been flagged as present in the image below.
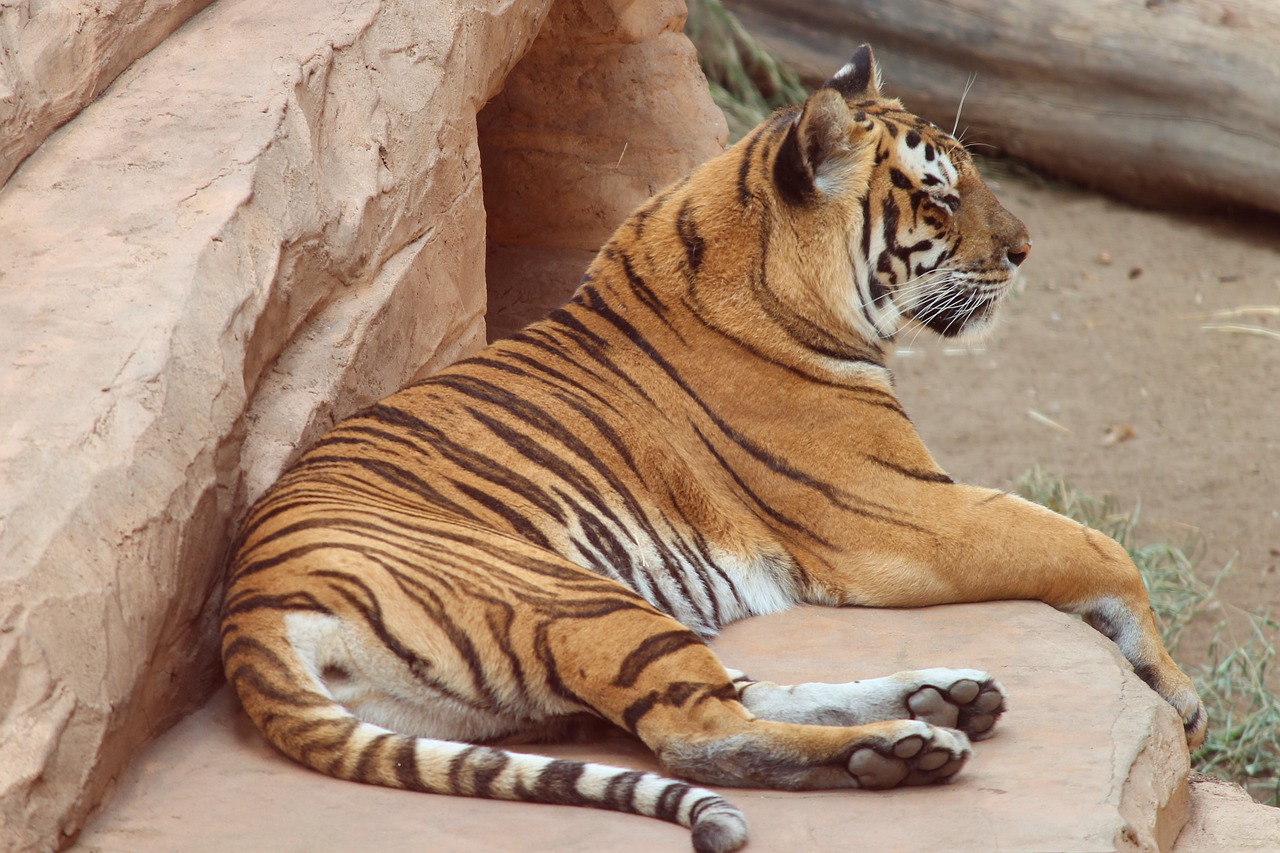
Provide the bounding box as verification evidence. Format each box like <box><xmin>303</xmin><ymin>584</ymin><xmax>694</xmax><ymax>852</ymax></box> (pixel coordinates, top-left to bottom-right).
<box><xmin>541</xmin><ymin>590</ymin><xmax>970</xmax><ymax>789</ymax></box>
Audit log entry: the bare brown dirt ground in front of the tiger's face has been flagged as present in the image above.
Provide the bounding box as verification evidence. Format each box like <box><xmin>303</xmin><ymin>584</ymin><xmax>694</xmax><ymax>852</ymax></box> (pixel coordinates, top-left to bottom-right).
<box><xmin>895</xmin><ymin>179</ymin><xmax>1280</xmax><ymax>657</ymax></box>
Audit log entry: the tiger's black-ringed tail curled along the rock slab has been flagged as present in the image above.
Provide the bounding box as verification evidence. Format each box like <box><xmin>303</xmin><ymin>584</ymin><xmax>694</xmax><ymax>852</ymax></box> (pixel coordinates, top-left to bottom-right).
<box><xmin>223</xmin><ymin>622</ymin><xmax>748</xmax><ymax>853</ymax></box>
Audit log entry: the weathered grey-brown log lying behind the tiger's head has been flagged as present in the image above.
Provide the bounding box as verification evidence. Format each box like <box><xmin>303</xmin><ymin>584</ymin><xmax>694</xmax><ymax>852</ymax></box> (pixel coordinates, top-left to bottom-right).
<box><xmin>728</xmin><ymin>0</ymin><xmax>1280</xmax><ymax>211</ymax></box>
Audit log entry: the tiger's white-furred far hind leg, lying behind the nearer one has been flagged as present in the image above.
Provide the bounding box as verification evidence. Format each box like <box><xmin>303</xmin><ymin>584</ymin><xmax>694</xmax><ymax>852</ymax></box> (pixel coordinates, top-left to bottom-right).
<box><xmin>728</xmin><ymin>667</ymin><xmax>1005</xmax><ymax>740</ymax></box>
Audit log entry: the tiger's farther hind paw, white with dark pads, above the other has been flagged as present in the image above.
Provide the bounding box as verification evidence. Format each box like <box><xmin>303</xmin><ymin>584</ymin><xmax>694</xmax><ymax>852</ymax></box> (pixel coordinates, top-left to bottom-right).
<box><xmin>892</xmin><ymin>669</ymin><xmax>1005</xmax><ymax>740</ymax></box>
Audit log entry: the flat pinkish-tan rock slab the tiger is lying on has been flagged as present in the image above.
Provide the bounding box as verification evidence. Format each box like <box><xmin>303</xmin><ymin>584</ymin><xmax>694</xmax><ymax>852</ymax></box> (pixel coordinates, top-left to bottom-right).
<box><xmin>81</xmin><ymin>602</ymin><xmax>1192</xmax><ymax>853</ymax></box>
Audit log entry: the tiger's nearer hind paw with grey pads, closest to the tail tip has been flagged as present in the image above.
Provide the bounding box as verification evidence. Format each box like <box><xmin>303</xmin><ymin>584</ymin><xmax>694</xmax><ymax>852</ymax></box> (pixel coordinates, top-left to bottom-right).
<box><xmin>849</xmin><ymin>720</ymin><xmax>972</xmax><ymax>789</ymax></box>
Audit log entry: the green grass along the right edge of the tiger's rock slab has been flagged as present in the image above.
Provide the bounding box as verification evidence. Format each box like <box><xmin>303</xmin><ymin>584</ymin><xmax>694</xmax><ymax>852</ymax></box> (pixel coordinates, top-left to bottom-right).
<box><xmin>1016</xmin><ymin>469</ymin><xmax>1280</xmax><ymax>806</ymax></box>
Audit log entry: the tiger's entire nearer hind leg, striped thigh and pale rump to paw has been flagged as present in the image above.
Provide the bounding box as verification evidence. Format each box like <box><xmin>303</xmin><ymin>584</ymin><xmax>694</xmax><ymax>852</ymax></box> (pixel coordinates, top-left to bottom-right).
<box><xmin>270</xmin><ymin>522</ymin><xmax>970</xmax><ymax>794</ymax></box>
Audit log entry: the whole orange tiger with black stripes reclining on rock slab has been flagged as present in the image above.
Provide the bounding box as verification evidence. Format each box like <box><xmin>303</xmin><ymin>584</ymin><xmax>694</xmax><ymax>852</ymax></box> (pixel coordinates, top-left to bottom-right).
<box><xmin>221</xmin><ymin>45</ymin><xmax>1206</xmax><ymax>853</ymax></box>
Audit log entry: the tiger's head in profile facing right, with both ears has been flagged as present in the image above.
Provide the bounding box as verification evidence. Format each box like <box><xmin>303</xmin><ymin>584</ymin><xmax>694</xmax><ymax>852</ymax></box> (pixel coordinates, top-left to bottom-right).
<box><xmin>686</xmin><ymin>45</ymin><xmax>1030</xmax><ymax>351</ymax></box>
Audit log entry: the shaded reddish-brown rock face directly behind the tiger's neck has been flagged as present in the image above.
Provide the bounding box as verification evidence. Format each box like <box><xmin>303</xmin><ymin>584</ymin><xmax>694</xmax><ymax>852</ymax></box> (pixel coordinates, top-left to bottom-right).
<box><xmin>479</xmin><ymin>0</ymin><xmax>727</xmax><ymax>338</ymax></box>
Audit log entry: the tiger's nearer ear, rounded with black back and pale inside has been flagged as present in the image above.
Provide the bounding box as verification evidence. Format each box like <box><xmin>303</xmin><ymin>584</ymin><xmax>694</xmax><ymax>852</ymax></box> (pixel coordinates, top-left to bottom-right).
<box><xmin>773</xmin><ymin>88</ymin><xmax>863</xmax><ymax>205</ymax></box>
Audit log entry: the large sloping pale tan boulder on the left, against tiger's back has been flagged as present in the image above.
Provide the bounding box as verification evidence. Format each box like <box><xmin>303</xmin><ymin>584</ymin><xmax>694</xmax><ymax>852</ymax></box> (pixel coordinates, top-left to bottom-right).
<box><xmin>0</xmin><ymin>0</ymin><xmax>721</xmax><ymax>850</ymax></box>
